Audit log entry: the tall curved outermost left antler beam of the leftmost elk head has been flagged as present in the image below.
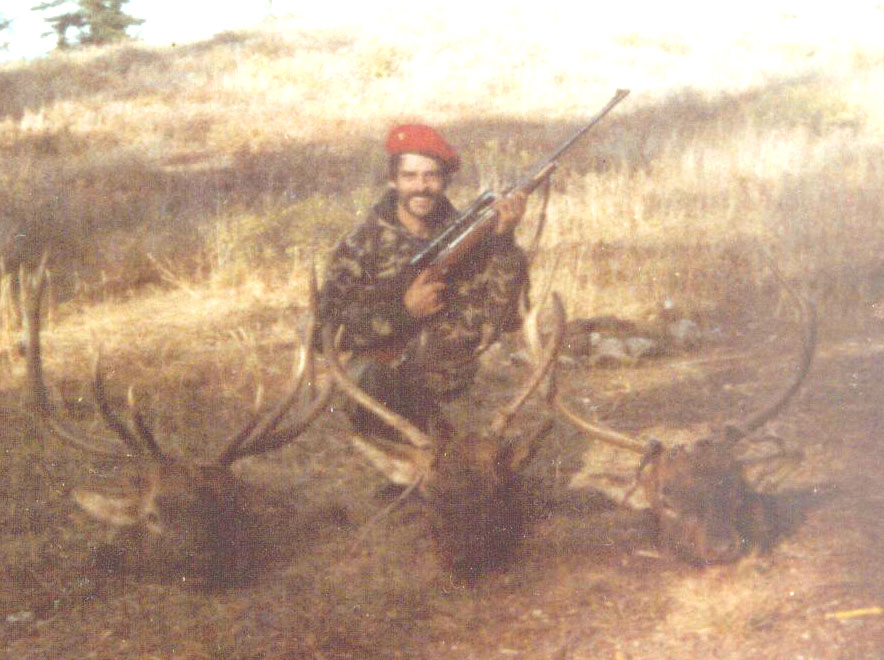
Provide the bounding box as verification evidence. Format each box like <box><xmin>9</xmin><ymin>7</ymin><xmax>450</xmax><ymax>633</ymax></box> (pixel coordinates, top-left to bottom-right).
<box><xmin>19</xmin><ymin>254</ymin><xmax>133</xmax><ymax>458</ymax></box>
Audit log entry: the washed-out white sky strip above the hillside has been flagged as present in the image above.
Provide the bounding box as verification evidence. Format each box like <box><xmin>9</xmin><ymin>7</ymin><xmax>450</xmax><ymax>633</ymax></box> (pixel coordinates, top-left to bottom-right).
<box><xmin>0</xmin><ymin>0</ymin><xmax>884</xmax><ymax>61</ymax></box>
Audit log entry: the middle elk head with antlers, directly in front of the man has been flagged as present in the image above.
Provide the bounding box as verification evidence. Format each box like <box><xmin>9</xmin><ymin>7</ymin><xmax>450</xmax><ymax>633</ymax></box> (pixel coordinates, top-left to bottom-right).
<box><xmin>324</xmin><ymin>295</ymin><xmax>565</xmax><ymax>582</ymax></box>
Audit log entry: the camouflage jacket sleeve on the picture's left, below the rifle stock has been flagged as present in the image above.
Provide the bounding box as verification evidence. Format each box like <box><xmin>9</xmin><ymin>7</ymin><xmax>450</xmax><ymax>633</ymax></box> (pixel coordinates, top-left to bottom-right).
<box><xmin>319</xmin><ymin>225</ymin><xmax>418</xmax><ymax>350</ymax></box>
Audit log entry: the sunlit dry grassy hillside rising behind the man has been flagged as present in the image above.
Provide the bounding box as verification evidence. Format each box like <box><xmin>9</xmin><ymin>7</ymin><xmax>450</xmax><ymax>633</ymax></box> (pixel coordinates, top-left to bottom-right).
<box><xmin>0</xmin><ymin>11</ymin><xmax>884</xmax><ymax>336</ymax></box>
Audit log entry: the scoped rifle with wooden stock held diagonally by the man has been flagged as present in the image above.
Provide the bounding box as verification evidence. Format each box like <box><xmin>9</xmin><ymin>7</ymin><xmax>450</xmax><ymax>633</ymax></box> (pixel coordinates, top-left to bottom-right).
<box><xmin>408</xmin><ymin>89</ymin><xmax>629</xmax><ymax>272</ymax></box>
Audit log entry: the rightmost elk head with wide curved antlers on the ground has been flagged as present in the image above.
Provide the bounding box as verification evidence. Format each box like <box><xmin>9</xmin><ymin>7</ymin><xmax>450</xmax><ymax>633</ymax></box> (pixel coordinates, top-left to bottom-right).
<box><xmin>551</xmin><ymin>271</ymin><xmax>816</xmax><ymax>565</ymax></box>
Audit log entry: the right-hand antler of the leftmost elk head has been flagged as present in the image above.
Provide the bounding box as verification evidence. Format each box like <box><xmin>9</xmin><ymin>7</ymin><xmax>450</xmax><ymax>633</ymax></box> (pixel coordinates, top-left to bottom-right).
<box><xmin>218</xmin><ymin>260</ymin><xmax>332</xmax><ymax>465</ymax></box>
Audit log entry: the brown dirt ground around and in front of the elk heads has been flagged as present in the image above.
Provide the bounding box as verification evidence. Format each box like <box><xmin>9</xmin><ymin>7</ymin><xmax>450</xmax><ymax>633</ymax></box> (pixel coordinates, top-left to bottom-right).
<box><xmin>0</xmin><ymin>296</ymin><xmax>884</xmax><ymax>660</ymax></box>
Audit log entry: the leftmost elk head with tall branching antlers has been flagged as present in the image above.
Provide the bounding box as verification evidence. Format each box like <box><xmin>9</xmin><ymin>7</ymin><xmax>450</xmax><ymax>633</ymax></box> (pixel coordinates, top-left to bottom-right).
<box><xmin>21</xmin><ymin>258</ymin><xmax>333</xmax><ymax>585</ymax></box>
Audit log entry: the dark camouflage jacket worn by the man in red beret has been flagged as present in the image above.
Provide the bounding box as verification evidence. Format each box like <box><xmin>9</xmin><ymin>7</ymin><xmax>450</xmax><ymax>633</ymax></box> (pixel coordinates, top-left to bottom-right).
<box><xmin>319</xmin><ymin>191</ymin><xmax>528</xmax><ymax>394</ymax></box>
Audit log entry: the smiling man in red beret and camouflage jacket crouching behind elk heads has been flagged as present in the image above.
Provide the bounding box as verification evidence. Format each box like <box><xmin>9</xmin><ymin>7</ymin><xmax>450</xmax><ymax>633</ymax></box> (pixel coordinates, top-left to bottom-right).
<box><xmin>319</xmin><ymin>124</ymin><xmax>527</xmax><ymax>439</ymax></box>
